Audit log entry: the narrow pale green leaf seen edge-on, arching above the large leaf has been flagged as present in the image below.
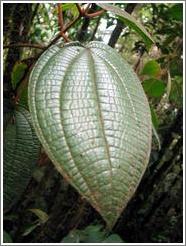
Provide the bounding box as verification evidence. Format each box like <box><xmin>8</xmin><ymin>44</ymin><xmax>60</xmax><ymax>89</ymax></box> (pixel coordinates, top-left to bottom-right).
<box><xmin>96</xmin><ymin>3</ymin><xmax>155</xmax><ymax>49</ymax></box>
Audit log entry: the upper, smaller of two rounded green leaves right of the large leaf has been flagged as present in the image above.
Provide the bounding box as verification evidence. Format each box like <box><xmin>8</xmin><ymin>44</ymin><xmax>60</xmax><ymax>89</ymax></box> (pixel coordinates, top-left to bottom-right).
<box><xmin>141</xmin><ymin>60</ymin><xmax>161</xmax><ymax>77</ymax></box>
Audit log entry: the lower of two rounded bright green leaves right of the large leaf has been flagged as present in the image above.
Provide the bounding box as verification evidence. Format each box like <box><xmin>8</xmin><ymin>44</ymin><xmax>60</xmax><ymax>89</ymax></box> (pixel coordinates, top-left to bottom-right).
<box><xmin>142</xmin><ymin>78</ymin><xmax>166</xmax><ymax>97</ymax></box>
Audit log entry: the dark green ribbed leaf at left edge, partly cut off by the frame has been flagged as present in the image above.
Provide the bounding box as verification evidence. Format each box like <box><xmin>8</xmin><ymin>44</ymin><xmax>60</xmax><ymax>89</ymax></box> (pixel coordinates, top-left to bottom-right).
<box><xmin>3</xmin><ymin>108</ymin><xmax>39</xmax><ymax>210</ymax></box>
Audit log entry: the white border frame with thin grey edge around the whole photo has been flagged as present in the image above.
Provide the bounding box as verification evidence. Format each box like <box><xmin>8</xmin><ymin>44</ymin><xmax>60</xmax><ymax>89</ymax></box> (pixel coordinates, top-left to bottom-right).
<box><xmin>1</xmin><ymin>0</ymin><xmax>186</xmax><ymax>245</ymax></box>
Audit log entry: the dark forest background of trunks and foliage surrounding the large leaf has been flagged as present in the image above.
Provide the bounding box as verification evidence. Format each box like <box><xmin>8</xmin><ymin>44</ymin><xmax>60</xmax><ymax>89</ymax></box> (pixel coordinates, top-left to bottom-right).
<box><xmin>3</xmin><ymin>3</ymin><xmax>183</xmax><ymax>243</ymax></box>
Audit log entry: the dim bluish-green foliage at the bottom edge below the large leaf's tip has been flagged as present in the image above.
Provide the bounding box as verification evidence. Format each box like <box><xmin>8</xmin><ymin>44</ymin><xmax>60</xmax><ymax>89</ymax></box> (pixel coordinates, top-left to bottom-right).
<box><xmin>62</xmin><ymin>225</ymin><xmax>123</xmax><ymax>243</ymax></box>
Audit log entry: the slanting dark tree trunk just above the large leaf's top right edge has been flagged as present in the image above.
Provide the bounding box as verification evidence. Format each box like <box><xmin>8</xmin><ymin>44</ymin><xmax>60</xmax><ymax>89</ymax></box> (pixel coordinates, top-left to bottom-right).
<box><xmin>108</xmin><ymin>3</ymin><xmax>137</xmax><ymax>48</ymax></box>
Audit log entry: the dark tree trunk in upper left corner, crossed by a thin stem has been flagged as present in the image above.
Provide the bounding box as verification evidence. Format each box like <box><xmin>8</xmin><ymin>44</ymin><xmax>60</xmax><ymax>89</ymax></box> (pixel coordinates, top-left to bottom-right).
<box><xmin>3</xmin><ymin>3</ymin><xmax>38</xmax><ymax>99</ymax></box>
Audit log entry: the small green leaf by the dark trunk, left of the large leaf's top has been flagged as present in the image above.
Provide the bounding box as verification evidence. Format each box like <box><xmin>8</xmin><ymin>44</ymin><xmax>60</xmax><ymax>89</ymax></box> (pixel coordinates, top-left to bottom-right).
<box><xmin>11</xmin><ymin>63</ymin><xmax>27</xmax><ymax>89</ymax></box>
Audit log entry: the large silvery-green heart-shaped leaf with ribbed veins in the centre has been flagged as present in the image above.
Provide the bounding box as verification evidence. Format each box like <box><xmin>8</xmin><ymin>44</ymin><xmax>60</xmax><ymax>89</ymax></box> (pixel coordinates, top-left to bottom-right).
<box><xmin>28</xmin><ymin>42</ymin><xmax>151</xmax><ymax>227</ymax></box>
